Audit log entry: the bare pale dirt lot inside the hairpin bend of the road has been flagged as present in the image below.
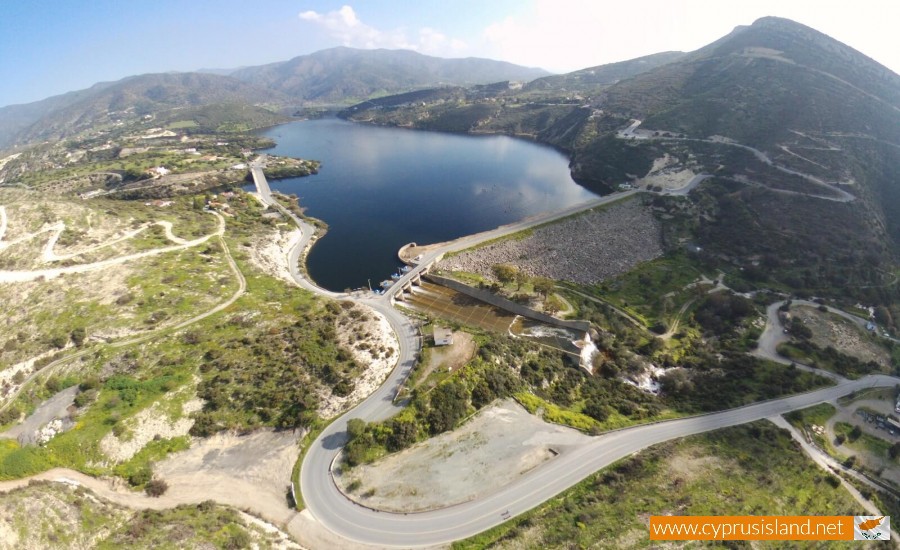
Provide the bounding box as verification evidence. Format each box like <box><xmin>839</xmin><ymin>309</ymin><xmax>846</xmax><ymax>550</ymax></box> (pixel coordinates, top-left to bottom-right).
<box><xmin>335</xmin><ymin>399</ymin><xmax>591</xmax><ymax>512</ymax></box>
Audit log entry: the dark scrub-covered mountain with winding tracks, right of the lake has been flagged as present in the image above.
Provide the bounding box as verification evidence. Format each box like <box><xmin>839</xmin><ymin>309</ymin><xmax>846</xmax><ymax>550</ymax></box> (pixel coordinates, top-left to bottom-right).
<box><xmin>347</xmin><ymin>17</ymin><xmax>900</xmax><ymax>301</ymax></box>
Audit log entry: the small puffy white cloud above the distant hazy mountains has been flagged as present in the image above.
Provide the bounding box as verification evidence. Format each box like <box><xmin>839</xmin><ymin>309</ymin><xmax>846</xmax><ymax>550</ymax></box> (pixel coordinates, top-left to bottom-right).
<box><xmin>299</xmin><ymin>6</ymin><xmax>466</xmax><ymax>57</ymax></box>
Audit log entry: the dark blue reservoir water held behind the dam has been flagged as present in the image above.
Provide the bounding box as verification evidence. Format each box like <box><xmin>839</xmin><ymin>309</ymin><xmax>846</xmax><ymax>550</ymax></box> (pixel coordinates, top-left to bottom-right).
<box><xmin>263</xmin><ymin>119</ymin><xmax>594</xmax><ymax>291</ymax></box>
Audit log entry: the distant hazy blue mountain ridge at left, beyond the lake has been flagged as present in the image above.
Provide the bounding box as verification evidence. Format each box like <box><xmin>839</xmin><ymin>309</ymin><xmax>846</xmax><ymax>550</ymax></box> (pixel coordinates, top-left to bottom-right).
<box><xmin>0</xmin><ymin>47</ymin><xmax>549</xmax><ymax>148</ymax></box>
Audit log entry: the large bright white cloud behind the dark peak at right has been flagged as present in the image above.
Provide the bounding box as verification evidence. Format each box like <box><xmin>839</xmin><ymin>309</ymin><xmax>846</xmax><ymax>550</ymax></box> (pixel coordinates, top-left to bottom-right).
<box><xmin>479</xmin><ymin>0</ymin><xmax>900</xmax><ymax>72</ymax></box>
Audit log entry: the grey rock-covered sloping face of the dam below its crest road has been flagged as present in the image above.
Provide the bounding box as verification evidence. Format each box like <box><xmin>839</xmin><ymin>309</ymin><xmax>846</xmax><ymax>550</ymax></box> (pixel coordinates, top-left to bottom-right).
<box><xmin>438</xmin><ymin>199</ymin><xmax>663</xmax><ymax>284</ymax></box>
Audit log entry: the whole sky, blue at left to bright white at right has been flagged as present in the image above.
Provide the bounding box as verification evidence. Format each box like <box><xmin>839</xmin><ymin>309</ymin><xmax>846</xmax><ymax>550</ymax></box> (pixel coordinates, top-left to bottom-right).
<box><xmin>0</xmin><ymin>0</ymin><xmax>900</xmax><ymax>106</ymax></box>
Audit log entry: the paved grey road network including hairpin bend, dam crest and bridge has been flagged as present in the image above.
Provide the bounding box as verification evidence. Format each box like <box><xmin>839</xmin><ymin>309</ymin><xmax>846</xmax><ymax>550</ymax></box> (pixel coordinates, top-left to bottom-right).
<box><xmin>251</xmin><ymin>162</ymin><xmax>900</xmax><ymax>548</ymax></box>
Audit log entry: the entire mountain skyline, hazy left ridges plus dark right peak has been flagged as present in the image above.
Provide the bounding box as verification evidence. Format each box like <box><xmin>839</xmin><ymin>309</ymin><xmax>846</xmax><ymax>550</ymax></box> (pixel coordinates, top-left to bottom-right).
<box><xmin>0</xmin><ymin>17</ymin><xmax>900</xmax><ymax>302</ymax></box>
